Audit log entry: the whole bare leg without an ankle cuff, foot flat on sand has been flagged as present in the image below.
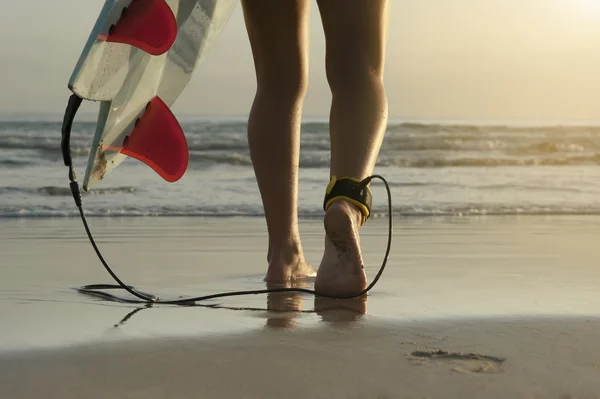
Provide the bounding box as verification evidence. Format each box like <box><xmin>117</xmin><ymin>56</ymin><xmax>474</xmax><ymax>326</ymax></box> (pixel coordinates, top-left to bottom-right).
<box><xmin>242</xmin><ymin>0</ymin><xmax>315</xmax><ymax>282</ymax></box>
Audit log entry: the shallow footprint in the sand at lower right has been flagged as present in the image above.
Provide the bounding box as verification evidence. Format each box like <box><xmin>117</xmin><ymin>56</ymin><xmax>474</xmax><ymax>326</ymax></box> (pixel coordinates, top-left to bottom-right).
<box><xmin>410</xmin><ymin>350</ymin><xmax>506</xmax><ymax>374</ymax></box>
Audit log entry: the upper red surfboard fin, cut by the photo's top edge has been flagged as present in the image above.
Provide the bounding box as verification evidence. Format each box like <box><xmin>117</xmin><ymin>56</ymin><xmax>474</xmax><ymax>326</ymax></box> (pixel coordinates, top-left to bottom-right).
<box><xmin>106</xmin><ymin>0</ymin><xmax>177</xmax><ymax>55</ymax></box>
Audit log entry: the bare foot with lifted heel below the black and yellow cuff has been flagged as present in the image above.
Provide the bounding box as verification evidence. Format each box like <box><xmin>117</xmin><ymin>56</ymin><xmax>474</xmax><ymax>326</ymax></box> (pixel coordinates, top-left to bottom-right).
<box><xmin>315</xmin><ymin>200</ymin><xmax>367</xmax><ymax>296</ymax></box>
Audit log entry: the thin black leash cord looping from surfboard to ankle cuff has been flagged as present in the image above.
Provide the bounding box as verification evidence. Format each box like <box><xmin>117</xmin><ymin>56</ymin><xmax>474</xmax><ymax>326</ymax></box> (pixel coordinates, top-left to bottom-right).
<box><xmin>61</xmin><ymin>94</ymin><xmax>393</xmax><ymax>306</ymax></box>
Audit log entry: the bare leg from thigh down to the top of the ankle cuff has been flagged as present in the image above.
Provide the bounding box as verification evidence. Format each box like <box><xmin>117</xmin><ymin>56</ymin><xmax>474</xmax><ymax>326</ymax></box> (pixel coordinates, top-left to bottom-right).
<box><xmin>318</xmin><ymin>0</ymin><xmax>389</xmax><ymax>179</ymax></box>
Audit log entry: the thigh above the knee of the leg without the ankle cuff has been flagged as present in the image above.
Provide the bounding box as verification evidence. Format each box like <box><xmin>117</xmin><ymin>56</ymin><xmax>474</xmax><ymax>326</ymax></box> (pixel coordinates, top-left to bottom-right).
<box><xmin>242</xmin><ymin>0</ymin><xmax>310</xmax><ymax>83</ymax></box>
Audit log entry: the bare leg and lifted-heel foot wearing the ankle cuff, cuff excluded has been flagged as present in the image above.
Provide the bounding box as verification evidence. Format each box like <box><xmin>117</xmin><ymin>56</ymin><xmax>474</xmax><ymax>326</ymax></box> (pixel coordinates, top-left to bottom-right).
<box><xmin>315</xmin><ymin>0</ymin><xmax>389</xmax><ymax>294</ymax></box>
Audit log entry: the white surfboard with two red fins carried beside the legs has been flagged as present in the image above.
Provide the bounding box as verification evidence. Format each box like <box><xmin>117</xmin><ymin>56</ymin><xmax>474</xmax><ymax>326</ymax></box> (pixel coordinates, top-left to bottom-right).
<box><xmin>69</xmin><ymin>0</ymin><xmax>238</xmax><ymax>191</ymax></box>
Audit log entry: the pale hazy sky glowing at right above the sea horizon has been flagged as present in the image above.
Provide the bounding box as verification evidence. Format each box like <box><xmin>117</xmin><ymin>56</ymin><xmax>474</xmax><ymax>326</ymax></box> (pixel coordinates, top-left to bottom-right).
<box><xmin>0</xmin><ymin>0</ymin><xmax>600</xmax><ymax>122</ymax></box>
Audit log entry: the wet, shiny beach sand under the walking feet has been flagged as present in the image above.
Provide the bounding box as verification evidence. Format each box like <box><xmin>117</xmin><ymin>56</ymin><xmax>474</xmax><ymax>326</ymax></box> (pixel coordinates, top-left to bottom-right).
<box><xmin>0</xmin><ymin>216</ymin><xmax>600</xmax><ymax>399</ymax></box>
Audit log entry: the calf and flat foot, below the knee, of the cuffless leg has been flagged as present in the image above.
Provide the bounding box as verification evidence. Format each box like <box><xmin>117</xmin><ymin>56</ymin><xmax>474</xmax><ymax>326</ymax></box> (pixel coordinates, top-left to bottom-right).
<box><xmin>248</xmin><ymin>90</ymin><xmax>314</xmax><ymax>281</ymax></box>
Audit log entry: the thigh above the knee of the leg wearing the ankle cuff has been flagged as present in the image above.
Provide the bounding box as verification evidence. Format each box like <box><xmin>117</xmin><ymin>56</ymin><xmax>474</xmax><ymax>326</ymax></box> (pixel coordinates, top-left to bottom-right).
<box><xmin>317</xmin><ymin>0</ymin><xmax>389</xmax><ymax>77</ymax></box>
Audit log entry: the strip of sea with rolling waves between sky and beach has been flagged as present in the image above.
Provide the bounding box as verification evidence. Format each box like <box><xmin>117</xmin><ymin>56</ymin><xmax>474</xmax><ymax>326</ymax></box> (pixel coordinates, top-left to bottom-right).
<box><xmin>0</xmin><ymin>119</ymin><xmax>600</xmax><ymax>218</ymax></box>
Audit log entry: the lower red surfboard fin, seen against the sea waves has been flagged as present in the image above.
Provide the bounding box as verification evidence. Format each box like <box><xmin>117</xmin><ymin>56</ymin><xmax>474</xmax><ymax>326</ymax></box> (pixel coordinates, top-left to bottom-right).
<box><xmin>121</xmin><ymin>97</ymin><xmax>189</xmax><ymax>183</ymax></box>
